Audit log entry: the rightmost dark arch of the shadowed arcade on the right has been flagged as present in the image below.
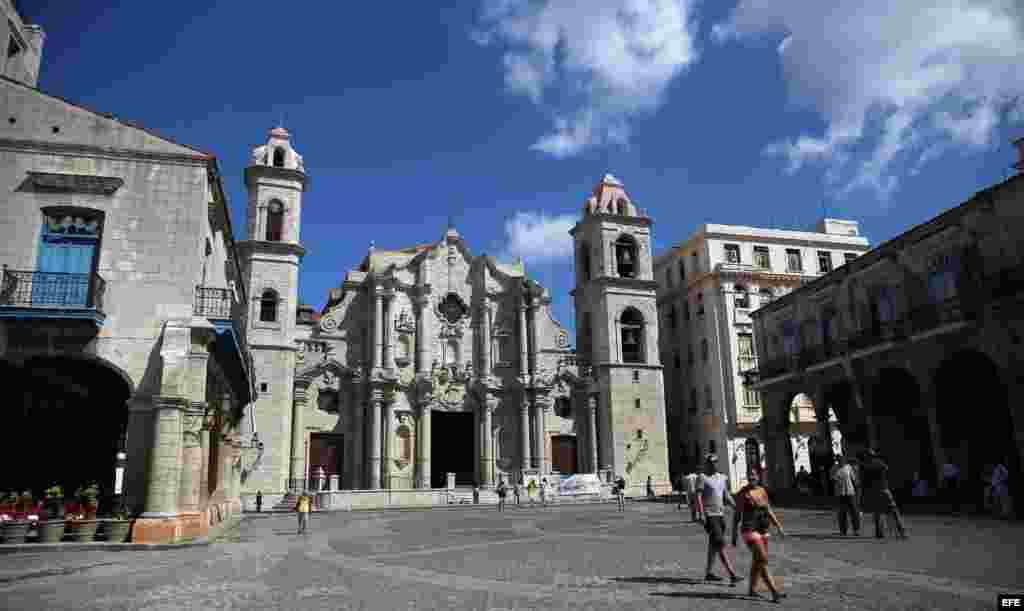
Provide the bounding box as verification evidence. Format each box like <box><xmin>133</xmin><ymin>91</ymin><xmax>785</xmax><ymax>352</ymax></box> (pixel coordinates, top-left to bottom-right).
<box><xmin>935</xmin><ymin>350</ymin><xmax>1022</xmax><ymax>513</ymax></box>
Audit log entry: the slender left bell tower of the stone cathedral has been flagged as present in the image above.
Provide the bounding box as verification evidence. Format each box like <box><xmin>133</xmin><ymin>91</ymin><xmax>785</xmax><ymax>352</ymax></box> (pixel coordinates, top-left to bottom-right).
<box><xmin>238</xmin><ymin>127</ymin><xmax>309</xmax><ymax>495</ymax></box>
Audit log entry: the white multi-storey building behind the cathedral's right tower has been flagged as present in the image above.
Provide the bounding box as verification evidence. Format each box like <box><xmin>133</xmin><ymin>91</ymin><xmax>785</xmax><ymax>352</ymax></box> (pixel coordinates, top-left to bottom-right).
<box><xmin>654</xmin><ymin>219</ymin><xmax>869</xmax><ymax>490</ymax></box>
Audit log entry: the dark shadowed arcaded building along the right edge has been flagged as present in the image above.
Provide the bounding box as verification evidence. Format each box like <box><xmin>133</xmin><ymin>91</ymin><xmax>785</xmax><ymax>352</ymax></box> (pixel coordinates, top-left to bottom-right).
<box><xmin>749</xmin><ymin>141</ymin><xmax>1024</xmax><ymax>511</ymax></box>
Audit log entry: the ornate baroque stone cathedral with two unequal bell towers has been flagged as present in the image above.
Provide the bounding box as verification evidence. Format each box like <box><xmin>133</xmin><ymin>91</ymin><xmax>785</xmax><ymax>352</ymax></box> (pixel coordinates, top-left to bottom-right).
<box><xmin>241</xmin><ymin>128</ymin><xmax>669</xmax><ymax>501</ymax></box>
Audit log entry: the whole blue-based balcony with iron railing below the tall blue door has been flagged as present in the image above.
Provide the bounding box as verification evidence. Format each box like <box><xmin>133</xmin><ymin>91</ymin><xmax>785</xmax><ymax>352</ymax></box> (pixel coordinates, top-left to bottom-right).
<box><xmin>0</xmin><ymin>265</ymin><xmax>106</xmax><ymax>324</ymax></box>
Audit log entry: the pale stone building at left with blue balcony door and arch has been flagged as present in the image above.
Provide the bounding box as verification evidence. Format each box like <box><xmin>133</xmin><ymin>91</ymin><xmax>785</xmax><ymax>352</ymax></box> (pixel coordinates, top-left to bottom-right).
<box><xmin>0</xmin><ymin>0</ymin><xmax>253</xmax><ymax>541</ymax></box>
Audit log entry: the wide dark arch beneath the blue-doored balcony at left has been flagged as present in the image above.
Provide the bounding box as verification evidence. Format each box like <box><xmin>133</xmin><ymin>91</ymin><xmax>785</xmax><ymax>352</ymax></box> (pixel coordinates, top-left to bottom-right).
<box><xmin>0</xmin><ymin>355</ymin><xmax>132</xmax><ymax>511</ymax></box>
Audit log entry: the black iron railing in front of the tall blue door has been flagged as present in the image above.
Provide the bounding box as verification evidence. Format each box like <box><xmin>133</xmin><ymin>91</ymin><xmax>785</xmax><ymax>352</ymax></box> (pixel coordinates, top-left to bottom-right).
<box><xmin>0</xmin><ymin>265</ymin><xmax>106</xmax><ymax>312</ymax></box>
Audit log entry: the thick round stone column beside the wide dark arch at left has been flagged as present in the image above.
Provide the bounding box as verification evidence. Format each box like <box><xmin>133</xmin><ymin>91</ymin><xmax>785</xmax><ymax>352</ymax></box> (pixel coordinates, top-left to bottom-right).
<box><xmin>141</xmin><ymin>397</ymin><xmax>187</xmax><ymax>518</ymax></box>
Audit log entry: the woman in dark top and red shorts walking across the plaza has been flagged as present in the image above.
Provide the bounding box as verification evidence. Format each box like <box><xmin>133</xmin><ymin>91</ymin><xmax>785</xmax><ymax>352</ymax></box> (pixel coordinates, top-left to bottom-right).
<box><xmin>732</xmin><ymin>474</ymin><xmax>785</xmax><ymax>603</ymax></box>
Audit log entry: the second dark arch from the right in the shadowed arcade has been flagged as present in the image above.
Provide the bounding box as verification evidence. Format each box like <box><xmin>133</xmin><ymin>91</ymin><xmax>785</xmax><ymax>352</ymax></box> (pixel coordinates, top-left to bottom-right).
<box><xmin>871</xmin><ymin>368</ymin><xmax>938</xmax><ymax>498</ymax></box>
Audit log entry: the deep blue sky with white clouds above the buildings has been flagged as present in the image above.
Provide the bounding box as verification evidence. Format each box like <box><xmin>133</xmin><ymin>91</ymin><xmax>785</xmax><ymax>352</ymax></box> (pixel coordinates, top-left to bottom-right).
<box><xmin>22</xmin><ymin>0</ymin><xmax>1024</xmax><ymax>339</ymax></box>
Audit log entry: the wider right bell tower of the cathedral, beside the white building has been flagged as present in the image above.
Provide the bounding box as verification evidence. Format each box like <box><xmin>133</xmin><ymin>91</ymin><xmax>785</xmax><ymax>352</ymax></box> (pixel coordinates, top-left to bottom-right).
<box><xmin>570</xmin><ymin>174</ymin><xmax>670</xmax><ymax>489</ymax></box>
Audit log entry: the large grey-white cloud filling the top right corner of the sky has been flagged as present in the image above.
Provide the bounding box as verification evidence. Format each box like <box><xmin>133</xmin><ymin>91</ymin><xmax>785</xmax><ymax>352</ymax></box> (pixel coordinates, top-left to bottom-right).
<box><xmin>713</xmin><ymin>0</ymin><xmax>1024</xmax><ymax>198</ymax></box>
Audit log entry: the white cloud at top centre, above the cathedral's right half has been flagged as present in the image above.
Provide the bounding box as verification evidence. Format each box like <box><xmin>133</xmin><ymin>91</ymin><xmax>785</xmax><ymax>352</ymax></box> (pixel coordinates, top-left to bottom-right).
<box><xmin>471</xmin><ymin>0</ymin><xmax>696</xmax><ymax>158</ymax></box>
